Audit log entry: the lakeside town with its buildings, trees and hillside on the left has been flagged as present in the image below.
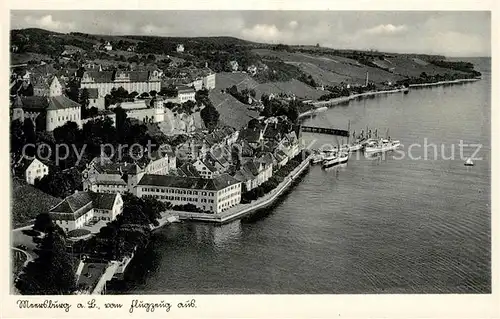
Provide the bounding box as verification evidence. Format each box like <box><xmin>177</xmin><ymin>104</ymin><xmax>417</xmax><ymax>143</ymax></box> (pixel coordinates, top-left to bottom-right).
<box><xmin>10</xmin><ymin>29</ymin><xmax>480</xmax><ymax>294</ymax></box>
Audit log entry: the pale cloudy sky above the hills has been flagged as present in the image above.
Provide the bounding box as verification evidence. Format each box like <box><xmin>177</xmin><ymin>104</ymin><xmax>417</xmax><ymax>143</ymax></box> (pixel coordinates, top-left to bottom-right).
<box><xmin>11</xmin><ymin>10</ymin><xmax>491</xmax><ymax>57</ymax></box>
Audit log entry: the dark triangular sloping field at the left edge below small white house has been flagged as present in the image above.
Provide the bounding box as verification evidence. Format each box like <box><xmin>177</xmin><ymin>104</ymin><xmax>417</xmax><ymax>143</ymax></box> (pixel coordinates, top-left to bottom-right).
<box><xmin>11</xmin><ymin>178</ymin><xmax>60</xmax><ymax>228</ymax></box>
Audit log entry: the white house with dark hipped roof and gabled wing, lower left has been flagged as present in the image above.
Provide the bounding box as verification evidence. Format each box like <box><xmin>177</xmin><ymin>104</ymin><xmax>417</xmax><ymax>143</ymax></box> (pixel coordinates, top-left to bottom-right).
<box><xmin>49</xmin><ymin>191</ymin><xmax>123</xmax><ymax>232</ymax></box>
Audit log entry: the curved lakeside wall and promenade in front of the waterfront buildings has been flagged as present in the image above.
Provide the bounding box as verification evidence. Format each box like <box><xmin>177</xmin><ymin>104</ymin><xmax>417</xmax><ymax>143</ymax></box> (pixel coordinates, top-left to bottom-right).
<box><xmin>174</xmin><ymin>155</ymin><xmax>311</xmax><ymax>224</ymax></box>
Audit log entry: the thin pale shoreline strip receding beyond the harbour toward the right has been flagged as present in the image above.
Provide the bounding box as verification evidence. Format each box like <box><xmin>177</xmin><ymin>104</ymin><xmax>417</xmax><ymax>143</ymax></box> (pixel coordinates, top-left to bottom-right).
<box><xmin>298</xmin><ymin>78</ymin><xmax>481</xmax><ymax>119</ymax></box>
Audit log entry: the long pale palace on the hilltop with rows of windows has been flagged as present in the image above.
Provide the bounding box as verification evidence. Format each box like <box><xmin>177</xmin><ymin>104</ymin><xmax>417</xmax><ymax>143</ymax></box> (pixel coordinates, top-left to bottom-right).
<box><xmin>80</xmin><ymin>70</ymin><xmax>161</xmax><ymax>97</ymax></box>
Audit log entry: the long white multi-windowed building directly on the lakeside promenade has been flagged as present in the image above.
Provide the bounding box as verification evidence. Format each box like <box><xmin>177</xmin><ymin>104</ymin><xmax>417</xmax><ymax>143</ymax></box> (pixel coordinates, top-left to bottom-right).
<box><xmin>135</xmin><ymin>174</ymin><xmax>241</xmax><ymax>214</ymax></box>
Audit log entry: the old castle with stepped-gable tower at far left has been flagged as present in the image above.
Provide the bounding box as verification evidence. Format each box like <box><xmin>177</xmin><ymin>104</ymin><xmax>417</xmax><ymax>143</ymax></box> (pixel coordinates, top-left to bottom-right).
<box><xmin>11</xmin><ymin>77</ymin><xmax>82</xmax><ymax>132</ymax></box>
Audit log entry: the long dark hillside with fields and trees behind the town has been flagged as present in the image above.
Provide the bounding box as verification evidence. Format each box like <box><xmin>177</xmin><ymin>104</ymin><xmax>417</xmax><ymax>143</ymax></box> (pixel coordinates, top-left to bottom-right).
<box><xmin>11</xmin><ymin>28</ymin><xmax>480</xmax><ymax>99</ymax></box>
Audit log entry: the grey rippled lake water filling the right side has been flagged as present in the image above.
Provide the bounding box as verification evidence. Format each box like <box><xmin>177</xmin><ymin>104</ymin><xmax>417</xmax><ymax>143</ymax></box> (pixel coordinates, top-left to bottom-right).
<box><xmin>112</xmin><ymin>61</ymin><xmax>491</xmax><ymax>294</ymax></box>
